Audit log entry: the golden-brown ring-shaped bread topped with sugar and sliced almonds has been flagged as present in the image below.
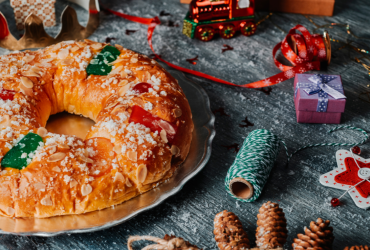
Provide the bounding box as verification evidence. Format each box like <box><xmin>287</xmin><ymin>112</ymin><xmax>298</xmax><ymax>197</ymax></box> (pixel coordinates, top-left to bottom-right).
<box><xmin>0</xmin><ymin>40</ymin><xmax>194</xmax><ymax>217</ymax></box>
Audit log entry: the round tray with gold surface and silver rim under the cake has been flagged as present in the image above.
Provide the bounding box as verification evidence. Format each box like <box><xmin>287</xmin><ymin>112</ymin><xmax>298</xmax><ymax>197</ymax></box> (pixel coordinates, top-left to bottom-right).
<box><xmin>0</xmin><ymin>64</ymin><xmax>215</xmax><ymax>237</ymax></box>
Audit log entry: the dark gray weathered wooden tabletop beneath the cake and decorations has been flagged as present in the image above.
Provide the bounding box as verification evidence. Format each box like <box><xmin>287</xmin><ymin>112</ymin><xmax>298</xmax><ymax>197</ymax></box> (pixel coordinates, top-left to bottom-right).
<box><xmin>0</xmin><ymin>0</ymin><xmax>370</xmax><ymax>250</ymax></box>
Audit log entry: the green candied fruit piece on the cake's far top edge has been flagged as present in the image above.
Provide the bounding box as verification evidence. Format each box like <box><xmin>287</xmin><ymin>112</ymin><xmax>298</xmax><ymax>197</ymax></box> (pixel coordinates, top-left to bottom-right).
<box><xmin>86</xmin><ymin>46</ymin><xmax>121</xmax><ymax>76</ymax></box>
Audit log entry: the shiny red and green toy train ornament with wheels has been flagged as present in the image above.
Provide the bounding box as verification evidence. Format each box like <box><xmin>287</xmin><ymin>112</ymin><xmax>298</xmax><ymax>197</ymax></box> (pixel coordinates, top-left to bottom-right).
<box><xmin>182</xmin><ymin>0</ymin><xmax>257</xmax><ymax>42</ymax></box>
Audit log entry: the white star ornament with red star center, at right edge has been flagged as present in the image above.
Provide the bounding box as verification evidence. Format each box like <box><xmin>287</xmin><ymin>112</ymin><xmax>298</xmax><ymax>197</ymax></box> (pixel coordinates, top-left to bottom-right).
<box><xmin>320</xmin><ymin>149</ymin><xmax>370</xmax><ymax>209</ymax></box>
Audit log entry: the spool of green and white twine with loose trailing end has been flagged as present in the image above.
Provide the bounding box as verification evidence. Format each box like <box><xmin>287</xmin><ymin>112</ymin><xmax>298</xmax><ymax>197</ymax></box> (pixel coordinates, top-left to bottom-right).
<box><xmin>225</xmin><ymin>126</ymin><xmax>368</xmax><ymax>202</ymax></box>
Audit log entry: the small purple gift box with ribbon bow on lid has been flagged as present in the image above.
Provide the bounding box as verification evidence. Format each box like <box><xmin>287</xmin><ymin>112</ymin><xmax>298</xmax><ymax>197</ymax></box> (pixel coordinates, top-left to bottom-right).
<box><xmin>294</xmin><ymin>74</ymin><xmax>346</xmax><ymax>124</ymax></box>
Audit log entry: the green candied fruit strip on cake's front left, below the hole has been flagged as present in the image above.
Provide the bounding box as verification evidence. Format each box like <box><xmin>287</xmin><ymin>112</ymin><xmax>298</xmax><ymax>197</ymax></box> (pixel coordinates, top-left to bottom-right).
<box><xmin>1</xmin><ymin>133</ymin><xmax>44</xmax><ymax>170</ymax></box>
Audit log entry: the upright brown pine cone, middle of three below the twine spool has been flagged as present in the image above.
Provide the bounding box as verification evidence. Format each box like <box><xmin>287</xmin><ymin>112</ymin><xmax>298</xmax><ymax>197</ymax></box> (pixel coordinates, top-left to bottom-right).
<box><xmin>256</xmin><ymin>201</ymin><xmax>288</xmax><ymax>249</ymax></box>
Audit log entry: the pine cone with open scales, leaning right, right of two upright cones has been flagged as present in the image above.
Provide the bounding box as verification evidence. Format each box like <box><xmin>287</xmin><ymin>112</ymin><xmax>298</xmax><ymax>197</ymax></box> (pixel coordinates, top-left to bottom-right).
<box><xmin>292</xmin><ymin>218</ymin><xmax>334</xmax><ymax>250</ymax></box>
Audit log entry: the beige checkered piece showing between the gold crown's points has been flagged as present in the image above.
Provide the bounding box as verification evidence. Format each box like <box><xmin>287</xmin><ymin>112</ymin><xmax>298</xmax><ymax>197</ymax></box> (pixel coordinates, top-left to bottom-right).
<box><xmin>10</xmin><ymin>0</ymin><xmax>56</xmax><ymax>30</ymax></box>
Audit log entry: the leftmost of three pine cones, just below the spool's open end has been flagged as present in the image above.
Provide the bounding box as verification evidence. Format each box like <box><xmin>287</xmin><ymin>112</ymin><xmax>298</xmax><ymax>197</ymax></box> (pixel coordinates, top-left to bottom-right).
<box><xmin>213</xmin><ymin>210</ymin><xmax>249</xmax><ymax>250</ymax></box>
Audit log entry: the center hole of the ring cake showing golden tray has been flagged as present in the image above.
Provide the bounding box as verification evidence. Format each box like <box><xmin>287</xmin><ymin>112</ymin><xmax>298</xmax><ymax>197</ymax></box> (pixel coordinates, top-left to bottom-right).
<box><xmin>46</xmin><ymin>112</ymin><xmax>95</xmax><ymax>139</ymax></box>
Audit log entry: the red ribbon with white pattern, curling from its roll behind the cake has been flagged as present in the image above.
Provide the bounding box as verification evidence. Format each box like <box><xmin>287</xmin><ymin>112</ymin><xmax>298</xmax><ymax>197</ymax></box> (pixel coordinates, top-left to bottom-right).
<box><xmin>106</xmin><ymin>9</ymin><xmax>326</xmax><ymax>88</ymax></box>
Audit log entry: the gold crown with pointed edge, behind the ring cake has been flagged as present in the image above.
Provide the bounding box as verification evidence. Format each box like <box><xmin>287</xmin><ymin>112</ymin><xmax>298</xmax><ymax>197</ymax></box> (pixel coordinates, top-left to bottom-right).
<box><xmin>0</xmin><ymin>0</ymin><xmax>100</xmax><ymax>50</ymax></box>
